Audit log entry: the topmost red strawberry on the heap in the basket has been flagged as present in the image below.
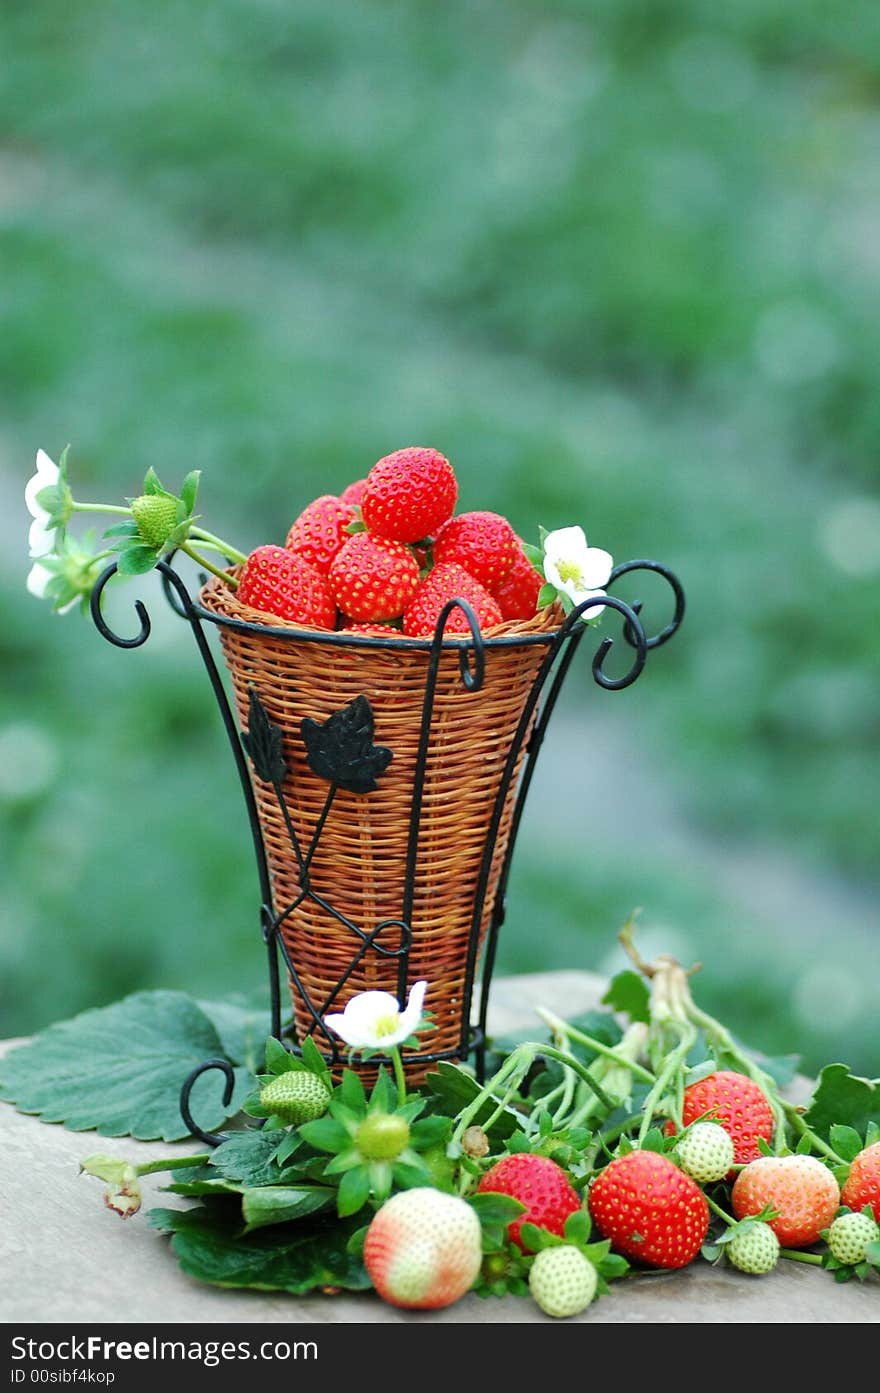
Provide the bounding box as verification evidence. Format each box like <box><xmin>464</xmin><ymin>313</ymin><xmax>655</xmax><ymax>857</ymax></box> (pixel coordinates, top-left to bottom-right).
<box><xmin>361</xmin><ymin>446</ymin><xmax>458</xmax><ymax>542</ymax></box>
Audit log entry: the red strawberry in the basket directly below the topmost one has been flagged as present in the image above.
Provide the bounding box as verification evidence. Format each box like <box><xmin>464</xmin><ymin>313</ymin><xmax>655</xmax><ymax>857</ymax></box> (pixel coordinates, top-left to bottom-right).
<box><xmin>327</xmin><ymin>532</ymin><xmax>419</xmax><ymax>623</ymax></box>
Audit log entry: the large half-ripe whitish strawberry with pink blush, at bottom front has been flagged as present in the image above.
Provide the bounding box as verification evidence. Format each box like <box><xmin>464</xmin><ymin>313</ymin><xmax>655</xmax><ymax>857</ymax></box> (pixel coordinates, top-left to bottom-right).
<box><xmin>363</xmin><ymin>1187</ymin><xmax>482</xmax><ymax>1311</ymax></box>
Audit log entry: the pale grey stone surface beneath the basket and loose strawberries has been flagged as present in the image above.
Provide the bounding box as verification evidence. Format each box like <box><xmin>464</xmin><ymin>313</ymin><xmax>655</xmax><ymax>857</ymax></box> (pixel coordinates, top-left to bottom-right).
<box><xmin>0</xmin><ymin>972</ymin><xmax>880</xmax><ymax>1325</ymax></box>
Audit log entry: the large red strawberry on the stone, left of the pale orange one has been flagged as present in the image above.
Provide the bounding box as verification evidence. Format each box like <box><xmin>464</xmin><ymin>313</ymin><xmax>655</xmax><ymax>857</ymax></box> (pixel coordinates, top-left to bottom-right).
<box><xmin>589</xmin><ymin>1151</ymin><xmax>709</xmax><ymax>1268</ymax></box>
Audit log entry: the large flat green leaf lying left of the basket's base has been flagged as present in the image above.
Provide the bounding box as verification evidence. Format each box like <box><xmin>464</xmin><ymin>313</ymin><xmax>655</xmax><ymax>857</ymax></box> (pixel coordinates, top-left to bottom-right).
<box><xmin>0</xmin><ymin>992</ymin><xmax>253</xmax><ymax>1141</ymax></box>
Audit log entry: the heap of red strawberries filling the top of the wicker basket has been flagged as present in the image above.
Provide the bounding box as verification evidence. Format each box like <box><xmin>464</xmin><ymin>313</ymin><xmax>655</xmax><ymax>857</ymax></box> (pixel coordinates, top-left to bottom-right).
<box><xmin>238</xmin><ymin>446</ymin><xmax>543</xmax><ymax>638</ymax></box>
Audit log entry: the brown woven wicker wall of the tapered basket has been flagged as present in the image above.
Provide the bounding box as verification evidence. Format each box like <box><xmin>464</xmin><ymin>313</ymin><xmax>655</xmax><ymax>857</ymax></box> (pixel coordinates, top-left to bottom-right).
<box><xmin>201</xmin><ymin>579</ymin><xmax>560</xmax><ymax>1080</ymax></box>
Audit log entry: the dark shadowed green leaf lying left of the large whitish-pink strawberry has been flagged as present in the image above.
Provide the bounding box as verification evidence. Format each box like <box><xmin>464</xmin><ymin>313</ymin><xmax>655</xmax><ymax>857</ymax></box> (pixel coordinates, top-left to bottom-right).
<box><xmin>149</xmin><ymin>1206</ymin><xmax>370</xmax><ymax>1294</ymax></box>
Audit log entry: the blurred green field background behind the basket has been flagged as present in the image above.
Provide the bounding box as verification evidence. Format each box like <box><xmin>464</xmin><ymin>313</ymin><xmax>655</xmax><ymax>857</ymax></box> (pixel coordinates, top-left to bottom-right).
<box><xmin>0</xmin><ymin>0</ymin><xmax>880</xmax><ymax>1074</ymax></box>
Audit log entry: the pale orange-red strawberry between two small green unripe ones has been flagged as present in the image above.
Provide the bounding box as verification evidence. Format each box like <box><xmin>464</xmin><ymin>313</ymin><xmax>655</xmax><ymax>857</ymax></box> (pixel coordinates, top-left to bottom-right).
<box><xmin>731</xmin><ymin>1156</ymin><xmax>840</xmax><ymax>1248</ymax></box>
